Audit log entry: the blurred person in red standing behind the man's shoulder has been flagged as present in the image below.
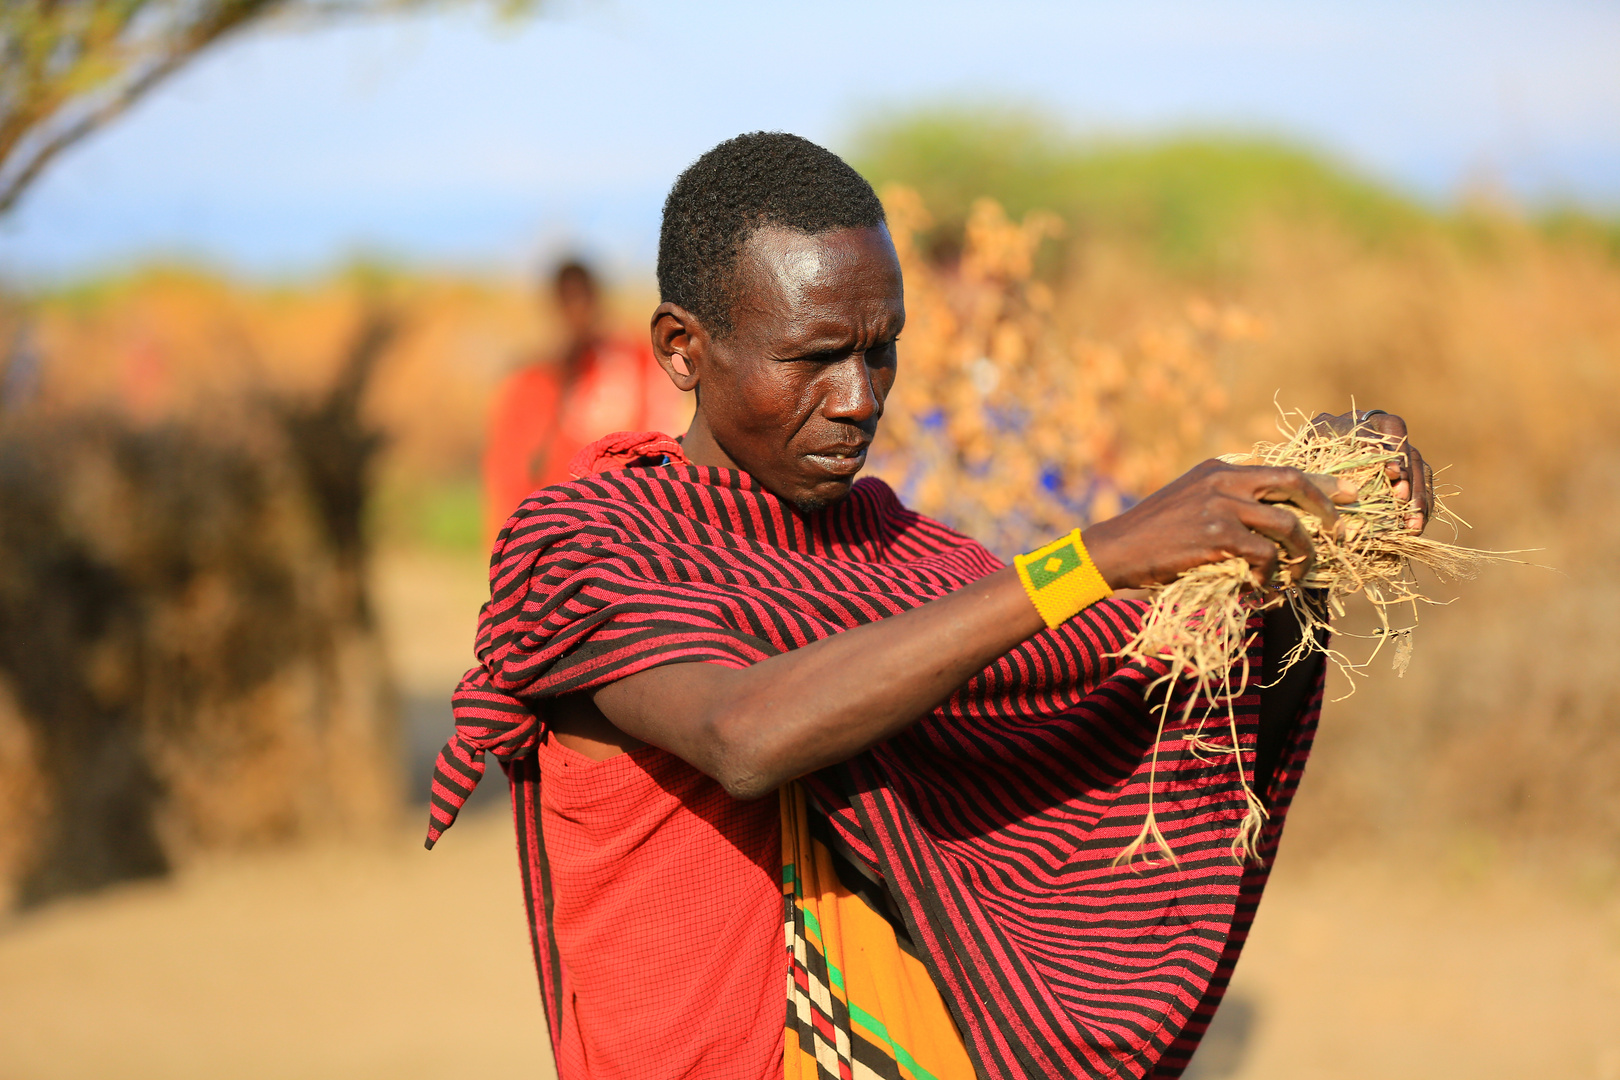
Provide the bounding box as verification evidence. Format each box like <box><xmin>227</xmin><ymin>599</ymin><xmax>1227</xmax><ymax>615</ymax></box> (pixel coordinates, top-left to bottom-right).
<box><xmin>483</xmin><ymin>259</ymin><xmax>692</xmax><ymax>542</ymax></box>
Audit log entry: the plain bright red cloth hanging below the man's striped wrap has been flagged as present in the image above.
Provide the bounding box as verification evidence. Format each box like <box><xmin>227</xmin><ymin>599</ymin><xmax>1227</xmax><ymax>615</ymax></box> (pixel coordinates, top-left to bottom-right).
<box><xmin>536</xmin><ymin>738</ymin><xmax>787</xmax><ymax>1080</ymax></box>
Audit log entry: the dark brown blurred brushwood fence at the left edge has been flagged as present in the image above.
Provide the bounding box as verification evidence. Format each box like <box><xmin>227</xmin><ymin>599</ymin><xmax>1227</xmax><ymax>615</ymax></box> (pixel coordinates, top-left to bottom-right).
<box><xmin>0</xmin><ymin>307</ymin><xmax>399</xmax><ymax>904</ymax></box>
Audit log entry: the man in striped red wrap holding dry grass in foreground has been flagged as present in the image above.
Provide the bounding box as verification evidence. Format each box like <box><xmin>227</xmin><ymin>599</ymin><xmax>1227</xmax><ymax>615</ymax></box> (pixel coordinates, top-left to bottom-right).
<box><xmin>429</xmin><ymin>133</ymin><xmax>1427</xmax><ymax>1080</ymax></box>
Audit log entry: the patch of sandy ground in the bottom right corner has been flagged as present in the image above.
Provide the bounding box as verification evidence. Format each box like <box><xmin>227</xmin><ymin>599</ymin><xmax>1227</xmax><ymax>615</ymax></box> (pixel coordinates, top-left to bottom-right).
<box><xmin>1200</xmin><ymin>850</ymin><xmax>1620</xmax><ymax>1080</ymax></box>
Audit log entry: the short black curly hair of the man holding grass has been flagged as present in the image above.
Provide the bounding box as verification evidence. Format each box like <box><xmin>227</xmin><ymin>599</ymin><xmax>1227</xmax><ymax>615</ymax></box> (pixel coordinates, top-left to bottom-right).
<box><xmin>658</xmin><ymin>131</ymin><xmax>885</xmax><ymax>337</ymax></box>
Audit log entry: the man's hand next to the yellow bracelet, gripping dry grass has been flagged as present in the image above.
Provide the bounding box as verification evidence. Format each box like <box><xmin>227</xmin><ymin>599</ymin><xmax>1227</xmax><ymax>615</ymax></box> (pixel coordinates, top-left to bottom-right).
<box><xmin>1084</xmin><ymin>460</ymin><xmax>1356</xmax><ymax>589</ymax></box>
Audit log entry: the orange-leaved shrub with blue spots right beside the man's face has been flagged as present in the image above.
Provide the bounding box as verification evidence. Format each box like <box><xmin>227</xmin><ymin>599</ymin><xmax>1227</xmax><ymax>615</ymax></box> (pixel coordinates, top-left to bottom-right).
<box><xmin>875</xmin><ymin>188</ymin><xmax>1259</xmax><ymax>555</ymax></box>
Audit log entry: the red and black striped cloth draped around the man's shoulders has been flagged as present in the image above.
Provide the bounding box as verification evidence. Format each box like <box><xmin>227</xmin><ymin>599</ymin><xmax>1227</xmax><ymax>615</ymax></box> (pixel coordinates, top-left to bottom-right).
<box><xmin>428</xmin><ymin>432</ymin><xmax>1320</xmax><ymax>1080</ymax></box>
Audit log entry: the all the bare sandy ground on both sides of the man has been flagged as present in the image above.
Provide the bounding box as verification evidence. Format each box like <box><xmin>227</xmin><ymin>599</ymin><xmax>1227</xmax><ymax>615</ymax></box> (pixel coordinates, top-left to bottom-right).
<box><xmin>0</xmin><ymin>554</ymin><xmax>1620</xmax><ymax>1080</ymax></box>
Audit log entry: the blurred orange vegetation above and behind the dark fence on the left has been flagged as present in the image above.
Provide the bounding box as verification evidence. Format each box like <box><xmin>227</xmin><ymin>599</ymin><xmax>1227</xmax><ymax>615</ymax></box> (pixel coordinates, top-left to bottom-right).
<box><xmin>34</xmin><ymin>270</ymin><xmax>544</xmax><ymax>476</ymax></box>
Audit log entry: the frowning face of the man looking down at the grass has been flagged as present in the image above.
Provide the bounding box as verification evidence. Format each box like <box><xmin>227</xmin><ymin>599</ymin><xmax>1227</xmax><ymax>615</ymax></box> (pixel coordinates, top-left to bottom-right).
<box><xmin>693</xmin><ymin>225</ymin><xmax>906</xmax><ymax>512</ymax></box>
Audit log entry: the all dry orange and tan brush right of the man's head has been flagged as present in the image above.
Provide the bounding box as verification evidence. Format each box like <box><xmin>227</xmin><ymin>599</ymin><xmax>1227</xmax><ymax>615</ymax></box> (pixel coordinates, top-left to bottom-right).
<box><xmin>880</xmin><ymin>183</ymin><xmax>1620</xmax><ymax>853</ymax></box>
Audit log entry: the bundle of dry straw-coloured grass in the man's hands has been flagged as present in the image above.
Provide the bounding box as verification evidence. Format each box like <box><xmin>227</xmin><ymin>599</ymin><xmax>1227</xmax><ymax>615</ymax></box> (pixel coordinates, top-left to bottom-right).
<box><xmin>1116</xmin><ymin>413</ymin><xmax>1516</xmax><ymax>863</ymax></box>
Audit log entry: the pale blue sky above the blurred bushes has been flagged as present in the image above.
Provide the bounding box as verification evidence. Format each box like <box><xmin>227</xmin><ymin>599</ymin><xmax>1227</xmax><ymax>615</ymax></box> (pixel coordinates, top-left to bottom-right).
<box><xmin>0</xmin><ymin>0</ymin><xmax>1620</xmax><ymax>279</ymax></box>
